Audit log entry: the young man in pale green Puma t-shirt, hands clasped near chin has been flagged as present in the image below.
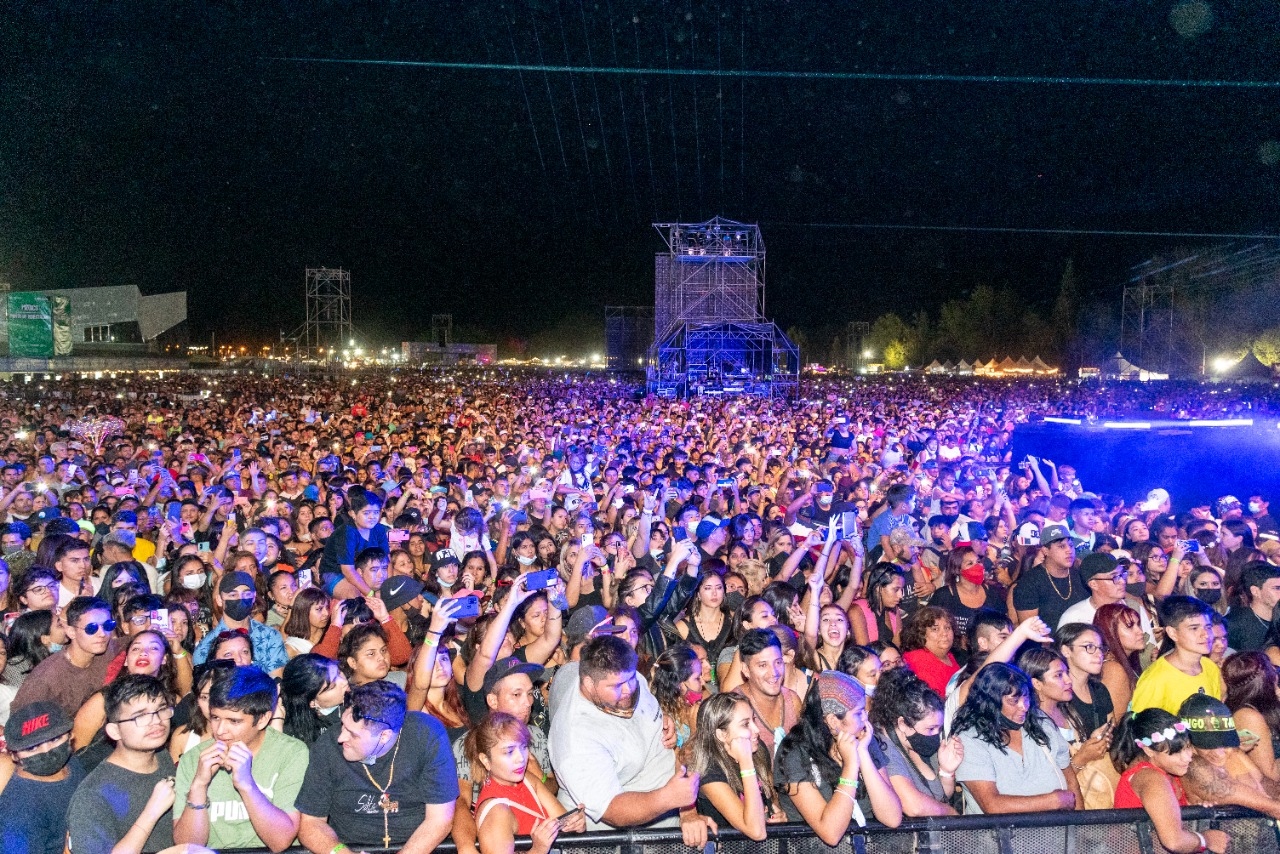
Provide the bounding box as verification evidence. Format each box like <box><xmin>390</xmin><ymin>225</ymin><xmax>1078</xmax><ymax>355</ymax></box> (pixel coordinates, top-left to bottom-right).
<box><xmin>173</xmin><ymin>665</ymin><xmax>307</xmax><ymax>851</ymax></box>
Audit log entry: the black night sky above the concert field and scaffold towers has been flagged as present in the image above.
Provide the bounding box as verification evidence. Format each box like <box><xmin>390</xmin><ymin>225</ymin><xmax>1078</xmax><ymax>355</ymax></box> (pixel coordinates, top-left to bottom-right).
<box><xmin>0</xmin><ymin>0</ymin><xmax>1280</xmax><ymax>350</ymax></box>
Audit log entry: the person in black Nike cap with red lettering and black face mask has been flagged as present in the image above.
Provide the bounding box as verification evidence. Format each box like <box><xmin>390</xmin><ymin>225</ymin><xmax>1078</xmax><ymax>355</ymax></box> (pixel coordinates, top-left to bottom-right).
<box><xmin>0</xmin><ymin>702</ymin><xmax>84</xmax><ymax>854</ymax></box>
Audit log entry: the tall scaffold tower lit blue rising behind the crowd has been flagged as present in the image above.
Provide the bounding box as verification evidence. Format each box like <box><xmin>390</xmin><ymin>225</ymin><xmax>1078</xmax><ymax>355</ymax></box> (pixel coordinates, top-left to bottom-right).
<box><xmin>648</xmin><ymin>216</ymin><xmax>800</xmax><ymax>397</ymax></box>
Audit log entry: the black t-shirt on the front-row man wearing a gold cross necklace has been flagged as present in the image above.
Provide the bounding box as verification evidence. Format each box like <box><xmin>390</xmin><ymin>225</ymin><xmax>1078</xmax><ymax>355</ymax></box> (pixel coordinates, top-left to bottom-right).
<box><xmin>294</xmin><ymin>712</ymin><xmax>458</xmax><ymax>848</ymax></box>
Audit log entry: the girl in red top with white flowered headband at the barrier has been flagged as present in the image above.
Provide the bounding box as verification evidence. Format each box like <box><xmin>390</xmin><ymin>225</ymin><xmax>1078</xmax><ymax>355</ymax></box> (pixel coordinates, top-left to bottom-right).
<box><xmin>1111</xmin><ymin>708</ymin><xmax>1230</xmax><ymax>854</ymax></box>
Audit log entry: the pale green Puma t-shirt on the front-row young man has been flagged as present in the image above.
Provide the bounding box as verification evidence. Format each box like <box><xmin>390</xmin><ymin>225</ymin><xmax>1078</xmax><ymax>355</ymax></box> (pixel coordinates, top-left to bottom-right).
<box><xmin>173</xmin><ymin>727</ymin><xmax>310</xmax><ymax>850</ymax></box>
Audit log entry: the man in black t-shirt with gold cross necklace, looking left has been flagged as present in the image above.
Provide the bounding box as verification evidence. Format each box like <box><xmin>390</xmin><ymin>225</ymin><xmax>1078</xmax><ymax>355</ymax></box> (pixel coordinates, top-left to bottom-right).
<box><xmin>297</xmin><ymin>680</ymin><xmax>458</xmax><ymax>854</ymax></box>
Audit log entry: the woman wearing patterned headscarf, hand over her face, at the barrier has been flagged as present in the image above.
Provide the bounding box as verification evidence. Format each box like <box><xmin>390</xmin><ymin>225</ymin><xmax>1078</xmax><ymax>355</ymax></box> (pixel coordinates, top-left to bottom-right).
<box><xmin>773</xmin><ymin>671</ymin><xmax>902</xmax><ymax>845</ymax></box>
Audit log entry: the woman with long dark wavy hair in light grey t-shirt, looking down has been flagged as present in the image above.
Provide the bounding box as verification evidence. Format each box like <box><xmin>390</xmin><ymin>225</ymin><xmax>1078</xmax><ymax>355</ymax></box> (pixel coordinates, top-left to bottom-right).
<box><xmin>951</xmin><ymin>662</ymin><xmax>1080</xmax><ymax>814</ymax></box>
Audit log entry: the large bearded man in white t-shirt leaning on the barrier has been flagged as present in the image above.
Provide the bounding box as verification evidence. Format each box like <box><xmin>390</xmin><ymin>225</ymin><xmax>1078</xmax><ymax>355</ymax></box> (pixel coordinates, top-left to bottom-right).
<box><xmin>550</xmin><ymin>635</ymin><xmax>714</xmax><ymax>846</ymax></box>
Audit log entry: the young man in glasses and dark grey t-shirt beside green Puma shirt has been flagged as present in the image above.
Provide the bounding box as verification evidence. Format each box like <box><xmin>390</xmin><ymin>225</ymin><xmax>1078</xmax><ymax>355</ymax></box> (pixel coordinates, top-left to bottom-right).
<box><xmin>67</xmin><ymin>673</ymin><xmax>213</xmax><ymax>854</ymax></box>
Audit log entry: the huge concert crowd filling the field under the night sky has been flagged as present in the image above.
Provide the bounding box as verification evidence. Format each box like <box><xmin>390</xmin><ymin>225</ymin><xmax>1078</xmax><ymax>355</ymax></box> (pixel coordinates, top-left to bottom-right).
<box><xmin>0</xmin><ymin>371</ymin><xmax>1280</xmax><ymax>854</ymax></box>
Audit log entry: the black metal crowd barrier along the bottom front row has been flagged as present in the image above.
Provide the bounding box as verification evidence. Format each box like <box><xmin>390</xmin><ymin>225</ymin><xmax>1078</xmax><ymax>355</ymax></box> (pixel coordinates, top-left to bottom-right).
<box><xmin>244</xmin><ymin>807</ymin><xmax>1280</xmax><ymax>854</ymax></box>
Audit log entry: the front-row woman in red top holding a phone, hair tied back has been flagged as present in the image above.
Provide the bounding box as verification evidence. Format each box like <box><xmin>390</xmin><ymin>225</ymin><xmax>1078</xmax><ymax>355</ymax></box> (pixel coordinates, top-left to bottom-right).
<box><xmin>465</xmin><ymin>712</ymin><xmax>586</xmax><ymax>854</ymax></box>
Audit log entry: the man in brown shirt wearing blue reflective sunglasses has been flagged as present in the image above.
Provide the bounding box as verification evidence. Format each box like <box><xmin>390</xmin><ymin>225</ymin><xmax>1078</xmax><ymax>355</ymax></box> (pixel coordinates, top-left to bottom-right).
<box><xmin>12</xmin><ymin>597</ymin><xmax>125</xmax><ymax>720</ymax></box>
